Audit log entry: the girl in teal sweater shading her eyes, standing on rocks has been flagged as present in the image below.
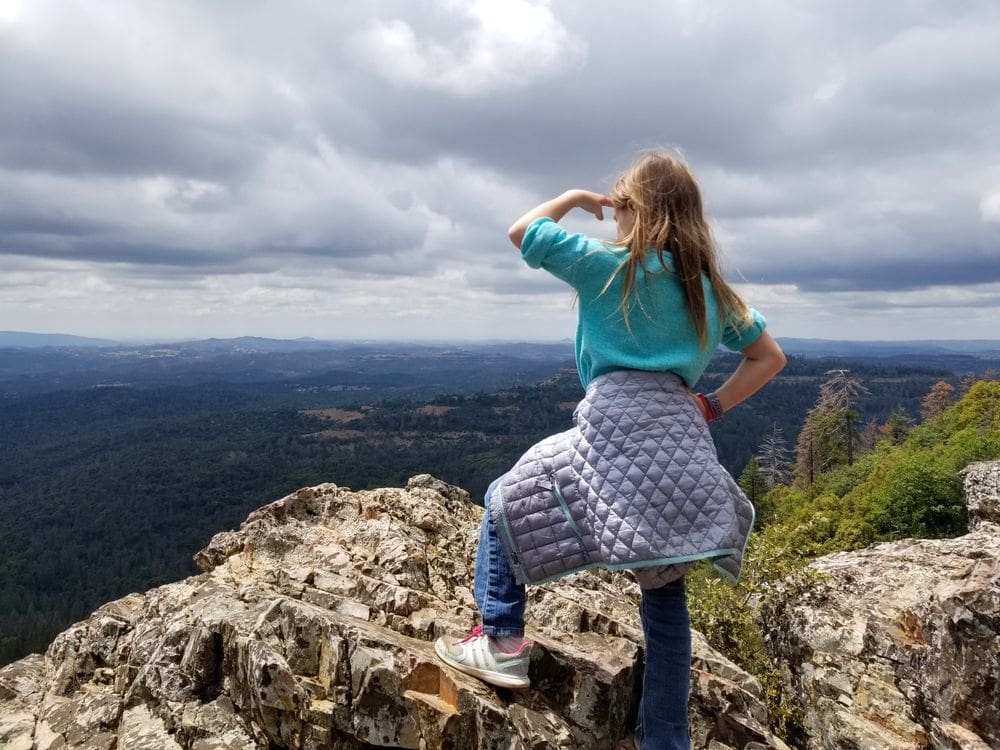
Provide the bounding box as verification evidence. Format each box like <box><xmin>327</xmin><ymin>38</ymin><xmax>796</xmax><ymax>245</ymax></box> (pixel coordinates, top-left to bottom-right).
<box><xmin>435</xmin><ymin>152</ymin><xmax>785</xmax><ymax>750</ymax></box>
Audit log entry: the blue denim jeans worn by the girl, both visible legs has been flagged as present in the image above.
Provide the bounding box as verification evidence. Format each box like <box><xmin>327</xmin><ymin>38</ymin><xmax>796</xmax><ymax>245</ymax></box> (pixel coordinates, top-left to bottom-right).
<box><xmin>473</xmin><ymin>480</ymin><xmax>691</xmax><ymax>750</ymax></box>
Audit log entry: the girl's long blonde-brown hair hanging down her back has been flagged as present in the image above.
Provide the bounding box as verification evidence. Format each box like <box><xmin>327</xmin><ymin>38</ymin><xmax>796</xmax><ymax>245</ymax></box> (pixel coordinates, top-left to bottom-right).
<box><xmin>605</xmin><ymin>151</ymin><xmax>750</xmax><ymax>349</ymax></box>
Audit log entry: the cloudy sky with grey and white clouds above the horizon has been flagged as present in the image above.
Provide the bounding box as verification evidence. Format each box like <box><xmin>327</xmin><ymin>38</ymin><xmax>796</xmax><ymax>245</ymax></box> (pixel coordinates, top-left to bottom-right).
<box><xmin>0</xmin><ymin>0</ymin><xmax>1000</xmax><ymax>339</ymax></box>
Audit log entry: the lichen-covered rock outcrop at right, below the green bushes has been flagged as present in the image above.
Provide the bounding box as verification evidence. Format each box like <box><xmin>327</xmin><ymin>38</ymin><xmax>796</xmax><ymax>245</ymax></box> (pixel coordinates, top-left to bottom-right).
<box><xmin>761</xmin><ymin>463</ymin><xmax>1000</xmax><ymax>750</ymax></box>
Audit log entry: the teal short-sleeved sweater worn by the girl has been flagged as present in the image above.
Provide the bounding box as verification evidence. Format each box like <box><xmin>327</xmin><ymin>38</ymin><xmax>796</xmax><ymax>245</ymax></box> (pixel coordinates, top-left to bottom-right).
<box><xmin>521</xmin><ymin>218</ymin><xmax>767</xmax><ymax>388</ymax></box>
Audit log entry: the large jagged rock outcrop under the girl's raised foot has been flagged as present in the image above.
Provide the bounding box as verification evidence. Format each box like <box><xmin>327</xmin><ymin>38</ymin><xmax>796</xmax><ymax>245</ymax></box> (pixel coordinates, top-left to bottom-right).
<box><xmin>0</xmin><ymin>475</ymin><xmax>788</xmax><ymax>750</ymax></box>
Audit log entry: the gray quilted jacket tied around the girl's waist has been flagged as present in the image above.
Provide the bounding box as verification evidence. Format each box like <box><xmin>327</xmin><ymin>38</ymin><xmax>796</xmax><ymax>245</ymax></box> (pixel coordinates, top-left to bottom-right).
<box><xmin>489</xmin><ymin>370</ymin><xmax>754</xmax><ymax>588</ymax></box>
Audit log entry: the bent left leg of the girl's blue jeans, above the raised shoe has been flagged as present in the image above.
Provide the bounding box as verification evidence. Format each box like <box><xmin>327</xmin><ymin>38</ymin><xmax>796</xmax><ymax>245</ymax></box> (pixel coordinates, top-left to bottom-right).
<box><xmin>472</xmin><ymin>479</ymin><xmax>528</xmax><ymax>637</ymax></box>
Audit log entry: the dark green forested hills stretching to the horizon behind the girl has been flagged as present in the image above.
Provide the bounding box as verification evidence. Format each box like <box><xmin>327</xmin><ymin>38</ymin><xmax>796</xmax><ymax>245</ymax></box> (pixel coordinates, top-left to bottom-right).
<box><xmin>0</xmin><ymin>340</ymin><xmax>996</xmax><ymax>663</ymax></box>
